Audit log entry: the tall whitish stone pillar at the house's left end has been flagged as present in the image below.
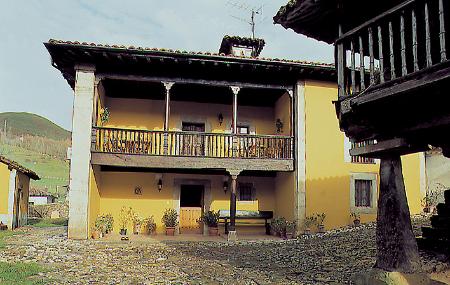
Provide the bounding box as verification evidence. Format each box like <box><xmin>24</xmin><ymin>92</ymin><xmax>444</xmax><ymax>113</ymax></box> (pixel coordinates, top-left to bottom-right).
<box><xmin>68</xmin><ymin>65</ymin><xmax>95</xmax><ymax>239</ymax></box>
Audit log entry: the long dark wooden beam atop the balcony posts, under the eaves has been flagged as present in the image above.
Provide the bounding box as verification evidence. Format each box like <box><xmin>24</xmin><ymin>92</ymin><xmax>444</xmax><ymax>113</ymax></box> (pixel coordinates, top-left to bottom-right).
<box><xmin>96</xmin><ymin>73</ymin><xmax>294</xmax><ymax>90</ymax></box>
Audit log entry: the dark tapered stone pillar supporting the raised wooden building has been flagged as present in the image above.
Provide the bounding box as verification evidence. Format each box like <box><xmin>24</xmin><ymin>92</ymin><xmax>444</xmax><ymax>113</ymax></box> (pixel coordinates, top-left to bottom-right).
<box><xmin>375</xmin><ymin>156</ymin><xmax>420</xmax><ymax>273</ymax></box>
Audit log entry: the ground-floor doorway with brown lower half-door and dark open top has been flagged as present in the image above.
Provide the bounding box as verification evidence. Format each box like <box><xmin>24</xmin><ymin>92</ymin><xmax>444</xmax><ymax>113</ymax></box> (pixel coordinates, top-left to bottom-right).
<box><xmin>180</xmin><ymin>184</ymin><xmax>205</xmax><ymax>234</ymax></box>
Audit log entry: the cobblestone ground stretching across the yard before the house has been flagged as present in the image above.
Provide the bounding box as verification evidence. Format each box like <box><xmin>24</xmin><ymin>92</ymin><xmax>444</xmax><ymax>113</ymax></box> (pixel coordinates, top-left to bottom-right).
<box><xmin>0</xmin><ymin>216</ymin><xmax>450</xmax><ymax>284</ymax></box>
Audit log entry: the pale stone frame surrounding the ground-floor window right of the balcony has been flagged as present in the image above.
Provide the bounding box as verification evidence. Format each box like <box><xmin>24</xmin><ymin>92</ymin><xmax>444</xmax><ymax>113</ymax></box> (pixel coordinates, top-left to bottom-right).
<box><xmin>350</xmin><ymin>173</ymin><xmax>378</xmax><ymax>214</ymax></box>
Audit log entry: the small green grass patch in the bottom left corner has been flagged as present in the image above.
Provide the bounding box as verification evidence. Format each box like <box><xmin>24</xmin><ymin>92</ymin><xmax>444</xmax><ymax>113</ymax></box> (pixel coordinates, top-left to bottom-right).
<box><xmin>0</xmin><ymin>262</ymin><xmax>47</xmax><ymax>285</ymax></box>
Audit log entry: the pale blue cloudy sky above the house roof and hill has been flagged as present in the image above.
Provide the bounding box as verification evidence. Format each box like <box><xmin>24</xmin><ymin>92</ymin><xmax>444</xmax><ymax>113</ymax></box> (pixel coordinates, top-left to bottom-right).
<box><xmin>0</xmin><ymin>0</ymin><xmax>333</xmax><ymax>130</ymax></box>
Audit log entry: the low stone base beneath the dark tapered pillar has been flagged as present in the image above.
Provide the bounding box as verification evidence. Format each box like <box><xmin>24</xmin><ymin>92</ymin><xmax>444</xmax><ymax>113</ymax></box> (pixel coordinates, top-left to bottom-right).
<box><xmin>352</xmin><ymin>268</ymin><xmax>445</xmax><ymax>285</ymax></box>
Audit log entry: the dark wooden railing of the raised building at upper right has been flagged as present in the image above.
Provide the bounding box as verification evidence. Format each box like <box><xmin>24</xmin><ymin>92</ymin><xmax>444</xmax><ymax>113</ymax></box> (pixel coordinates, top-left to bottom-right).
<box><xmin>336</xmin><ymin>0</ymin><xmax>450</xmax><ymax>98</ymax></box>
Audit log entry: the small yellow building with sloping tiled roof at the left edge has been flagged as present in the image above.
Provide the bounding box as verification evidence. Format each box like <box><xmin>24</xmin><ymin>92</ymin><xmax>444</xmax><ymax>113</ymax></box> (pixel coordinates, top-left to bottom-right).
<box><xmin>0</xmin><ymin>156</ymin><xmax>39</xmax><ymax>229</ymax></box>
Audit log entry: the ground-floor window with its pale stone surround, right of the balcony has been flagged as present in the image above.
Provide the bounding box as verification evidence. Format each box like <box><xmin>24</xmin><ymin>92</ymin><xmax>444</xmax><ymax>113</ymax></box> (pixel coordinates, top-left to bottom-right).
<box><xmin>350</xmin><ymin>173</ymin><xmax>378</xmax><ymax>214</ymax></box>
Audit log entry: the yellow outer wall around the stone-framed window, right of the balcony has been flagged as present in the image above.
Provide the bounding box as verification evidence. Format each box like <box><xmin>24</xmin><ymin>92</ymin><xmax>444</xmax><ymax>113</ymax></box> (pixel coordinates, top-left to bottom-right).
<box><xmin>305</xmin><ymin>81</ymin><xmax>426</xmax><ymax>229</ymax></box>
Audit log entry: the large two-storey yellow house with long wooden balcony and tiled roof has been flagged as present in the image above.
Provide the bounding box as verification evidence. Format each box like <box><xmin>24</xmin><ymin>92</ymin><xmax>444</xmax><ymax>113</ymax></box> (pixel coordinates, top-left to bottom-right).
<box><xmin>44</xmin><ymin>37</ymin><xmax>425</xmax><ymax>239</ymax></box>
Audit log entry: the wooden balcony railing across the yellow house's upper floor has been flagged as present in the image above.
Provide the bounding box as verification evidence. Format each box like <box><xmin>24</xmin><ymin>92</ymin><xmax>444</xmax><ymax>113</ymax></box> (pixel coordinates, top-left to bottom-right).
<box><xmin>91</xmin><ymin>127</ymin><xmax>293</xmax><ymax>159</ymax></box>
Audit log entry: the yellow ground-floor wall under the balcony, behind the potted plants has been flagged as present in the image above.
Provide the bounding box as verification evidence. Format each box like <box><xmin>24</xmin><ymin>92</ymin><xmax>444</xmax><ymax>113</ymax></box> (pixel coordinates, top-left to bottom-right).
<box><xmin>89</xmin><ymin>171</ymin><xmax>275</xmax><ymax>232</ymax></box>
